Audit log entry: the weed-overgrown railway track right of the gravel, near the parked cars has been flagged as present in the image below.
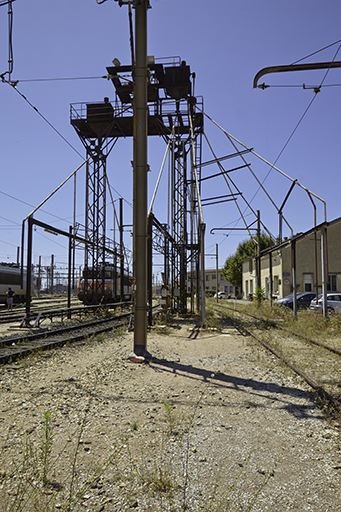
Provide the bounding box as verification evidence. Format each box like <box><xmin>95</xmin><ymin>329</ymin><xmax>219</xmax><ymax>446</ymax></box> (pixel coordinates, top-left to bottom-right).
<box><xmin>214</xmin><ymin>304</ymin><xmax>341</xmax><ymax>412</ymax></box>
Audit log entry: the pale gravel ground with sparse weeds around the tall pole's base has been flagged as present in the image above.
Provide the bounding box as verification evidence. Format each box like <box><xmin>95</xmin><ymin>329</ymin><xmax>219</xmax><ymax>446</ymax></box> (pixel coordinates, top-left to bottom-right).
<box><xmin>0</xmin><ymin>320</ymin><xmax>341</xmax><ymax>512</ymax></box>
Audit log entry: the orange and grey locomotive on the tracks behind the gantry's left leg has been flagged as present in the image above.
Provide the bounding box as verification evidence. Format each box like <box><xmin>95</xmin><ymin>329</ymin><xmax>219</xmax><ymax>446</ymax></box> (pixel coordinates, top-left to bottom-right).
<box><xmin>77</xmin><ymin>265</ymin><xmax>131</xmax><ymax>304</ymax></box>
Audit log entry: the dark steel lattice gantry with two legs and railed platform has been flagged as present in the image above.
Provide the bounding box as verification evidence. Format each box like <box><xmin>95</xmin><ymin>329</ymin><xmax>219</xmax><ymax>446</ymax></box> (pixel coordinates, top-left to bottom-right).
<box><xmin>71</xmin><ymin>57</ymin><xmax>203</xmax><ymax>321</ymax></box>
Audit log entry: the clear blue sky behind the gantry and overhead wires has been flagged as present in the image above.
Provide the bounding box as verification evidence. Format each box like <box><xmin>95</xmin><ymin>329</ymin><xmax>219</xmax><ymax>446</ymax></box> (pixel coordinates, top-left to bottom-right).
<box><xmin>0</xmin><ymin>0</ymin><xmax>341</xmax><ymax>274</ymax></box>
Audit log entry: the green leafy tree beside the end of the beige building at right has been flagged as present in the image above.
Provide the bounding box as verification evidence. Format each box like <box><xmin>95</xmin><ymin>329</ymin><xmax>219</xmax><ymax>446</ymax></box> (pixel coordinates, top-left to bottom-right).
<box><xmin>222</xmin><ymin>233</ymin><xmax>274</xmax><ymax>287</ymax></box>
